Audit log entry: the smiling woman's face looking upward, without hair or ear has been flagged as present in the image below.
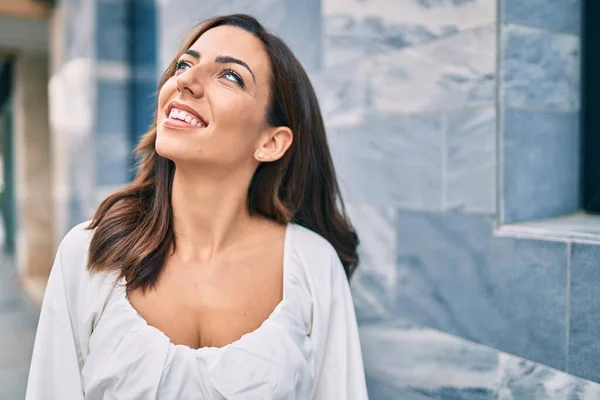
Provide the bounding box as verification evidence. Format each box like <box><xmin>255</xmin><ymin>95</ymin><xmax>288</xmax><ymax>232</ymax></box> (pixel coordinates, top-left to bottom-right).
<box><xmin>156</xmin><ymin>26</ymin><xmax>271</xmax><ymax>166</ymax></box>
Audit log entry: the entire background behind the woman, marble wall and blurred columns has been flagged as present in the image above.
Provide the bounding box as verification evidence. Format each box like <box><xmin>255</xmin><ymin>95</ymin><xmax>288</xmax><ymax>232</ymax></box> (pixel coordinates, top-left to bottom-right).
<box><xmin>0</xmin><ymin>0</ymin><xmax>600</xmax><ymax>400</ymax></box>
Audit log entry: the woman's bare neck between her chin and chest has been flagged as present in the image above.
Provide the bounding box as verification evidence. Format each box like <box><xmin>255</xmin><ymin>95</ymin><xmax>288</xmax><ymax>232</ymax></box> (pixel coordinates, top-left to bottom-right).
<box><xmin>171</xmin><ymin>163</ymin><xmax>252</xmax><ymax>263</ymax></box>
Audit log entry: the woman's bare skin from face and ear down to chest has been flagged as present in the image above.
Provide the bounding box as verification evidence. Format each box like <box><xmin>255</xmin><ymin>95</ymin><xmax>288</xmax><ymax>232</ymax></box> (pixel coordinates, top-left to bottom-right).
<box><xmin>129</xmin><ymin>26</ymin><xmax>294</xmax><ymax>348</ymax></box>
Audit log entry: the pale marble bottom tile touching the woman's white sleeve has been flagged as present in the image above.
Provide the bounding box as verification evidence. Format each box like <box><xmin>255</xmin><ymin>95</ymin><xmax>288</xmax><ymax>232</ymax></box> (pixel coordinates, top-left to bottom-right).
<box><xmin>360</xmin><ymin>319</ymin><xmax>498</xmax><ymax>399</ymax></box>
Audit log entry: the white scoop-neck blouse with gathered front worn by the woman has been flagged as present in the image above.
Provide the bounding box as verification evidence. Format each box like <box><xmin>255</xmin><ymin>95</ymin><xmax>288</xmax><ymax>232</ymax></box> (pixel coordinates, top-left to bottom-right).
<box><xmin>26</xmin><ymin>223</ymin><xmax>368</xmax><ymax>400</ymax></box>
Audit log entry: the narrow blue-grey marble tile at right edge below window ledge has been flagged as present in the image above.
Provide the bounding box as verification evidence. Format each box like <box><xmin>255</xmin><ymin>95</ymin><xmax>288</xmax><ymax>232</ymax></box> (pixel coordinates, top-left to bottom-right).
<box><xmin>569</xmin><ymin>243</ymin><xmax>600</xmax><ymax>382</ymax></box>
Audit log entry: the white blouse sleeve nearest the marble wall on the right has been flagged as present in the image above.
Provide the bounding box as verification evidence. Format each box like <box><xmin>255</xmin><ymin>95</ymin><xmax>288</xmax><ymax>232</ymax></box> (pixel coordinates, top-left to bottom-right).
<box><xmin>295</xmin><ymin>228</ymin><xmax>368</xmax><ymax>400</ymax></box>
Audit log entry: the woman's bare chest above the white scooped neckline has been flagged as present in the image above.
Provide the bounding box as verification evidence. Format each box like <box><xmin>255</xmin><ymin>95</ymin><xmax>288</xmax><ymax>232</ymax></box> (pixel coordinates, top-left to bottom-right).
<box><xmin>129</xmin><ymin>255</ymin><xmax>283</xmax><ymax>348</ymax></box>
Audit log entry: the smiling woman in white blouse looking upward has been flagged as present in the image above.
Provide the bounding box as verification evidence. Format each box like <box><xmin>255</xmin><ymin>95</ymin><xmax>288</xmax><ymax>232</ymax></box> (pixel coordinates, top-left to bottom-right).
<box><xmin>27</xmin><ymin>15</ymin><xmax>367</xmax><ymax>400</ymax></box>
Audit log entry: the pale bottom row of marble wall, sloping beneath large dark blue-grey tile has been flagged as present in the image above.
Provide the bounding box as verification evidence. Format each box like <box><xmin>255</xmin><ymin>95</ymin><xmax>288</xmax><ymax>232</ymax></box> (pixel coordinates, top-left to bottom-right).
<box><xmin>360</xmin><ymin>319</ymin><xmax>600</xmax><ymax>400</ymax></box>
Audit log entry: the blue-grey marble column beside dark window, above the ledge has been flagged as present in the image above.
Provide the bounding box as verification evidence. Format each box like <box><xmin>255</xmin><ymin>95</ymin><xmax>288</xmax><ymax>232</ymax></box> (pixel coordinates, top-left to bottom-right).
<box><xmin>498</xmin><ymin>0</ymin><xmax>581</xmax><ymax>222</ymax></box>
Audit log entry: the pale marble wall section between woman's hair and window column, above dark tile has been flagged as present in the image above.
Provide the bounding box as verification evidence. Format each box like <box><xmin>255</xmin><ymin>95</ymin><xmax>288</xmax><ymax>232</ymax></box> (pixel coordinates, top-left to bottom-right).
<box><xmin>313</xmin><ymin>0</ymin><xmax>496</xmax><ymax>213</ymax></box>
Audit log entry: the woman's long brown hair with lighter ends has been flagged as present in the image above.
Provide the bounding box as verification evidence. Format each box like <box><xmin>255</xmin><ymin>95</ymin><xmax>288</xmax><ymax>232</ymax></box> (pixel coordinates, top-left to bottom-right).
<box><xmin>88</xmin><ymin>14</ymin><xmax>358</xmax><ymax>290</ymax></box>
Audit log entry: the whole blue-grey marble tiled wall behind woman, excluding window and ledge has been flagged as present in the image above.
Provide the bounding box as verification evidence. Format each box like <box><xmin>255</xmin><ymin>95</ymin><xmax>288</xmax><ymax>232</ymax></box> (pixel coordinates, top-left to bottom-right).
<box><xmin>159</xmin><ymin>0</ymin><xmax>600</xmax><ymax>399</ymax></box>
